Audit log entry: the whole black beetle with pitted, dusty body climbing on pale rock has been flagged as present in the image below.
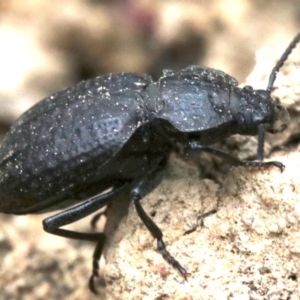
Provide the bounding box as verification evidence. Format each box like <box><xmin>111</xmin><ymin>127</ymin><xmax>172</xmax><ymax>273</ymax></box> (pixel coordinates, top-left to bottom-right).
<box><xmin>0</xmin><ymin>33</ymin><xmax>300</xmax><ymax>292</ymax></box>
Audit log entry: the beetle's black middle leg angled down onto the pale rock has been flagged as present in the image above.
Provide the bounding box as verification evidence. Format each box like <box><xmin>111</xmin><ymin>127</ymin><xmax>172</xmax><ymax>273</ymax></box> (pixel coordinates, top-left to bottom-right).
<box><xmin>131</xmin><ymin>168</ymin><xmax>187</xmax><ymax>278</ymax></box>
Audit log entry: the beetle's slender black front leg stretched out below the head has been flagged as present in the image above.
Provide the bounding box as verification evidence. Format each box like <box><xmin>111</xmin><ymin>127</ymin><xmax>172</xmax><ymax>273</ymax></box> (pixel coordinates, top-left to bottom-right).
<box><xmin>189</xmin><ymin>141</ymin><xmax>285</xmax><ymax>172</ymax></box>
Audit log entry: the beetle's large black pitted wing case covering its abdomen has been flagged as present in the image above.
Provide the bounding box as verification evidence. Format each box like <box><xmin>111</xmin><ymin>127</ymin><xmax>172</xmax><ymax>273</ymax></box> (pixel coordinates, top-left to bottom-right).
<box><xmin>0</xmin><ymin>73</ymin><xmax>150</xmax><ymax>212</ymax></box>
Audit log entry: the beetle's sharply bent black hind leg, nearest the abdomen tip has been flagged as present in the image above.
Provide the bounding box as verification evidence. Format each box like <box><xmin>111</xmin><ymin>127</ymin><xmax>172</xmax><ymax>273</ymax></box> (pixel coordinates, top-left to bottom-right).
<box><xmin>43</xmin><ymin>182</ymin><xmax>129</xmax><ymax>294</ymax></box>
